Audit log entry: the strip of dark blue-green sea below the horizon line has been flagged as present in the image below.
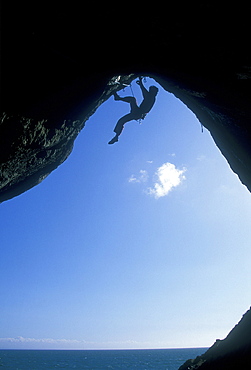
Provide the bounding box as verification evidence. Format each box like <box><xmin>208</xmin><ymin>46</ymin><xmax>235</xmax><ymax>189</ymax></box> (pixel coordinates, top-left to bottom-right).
<box><xmin>0</xmin><ymin>348</ymin><xmax>206</xmax><ymax>370</ymax></box>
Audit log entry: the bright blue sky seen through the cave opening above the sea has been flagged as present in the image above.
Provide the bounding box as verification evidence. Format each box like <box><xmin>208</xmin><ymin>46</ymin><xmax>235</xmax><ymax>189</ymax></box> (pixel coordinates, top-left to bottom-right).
<box><xmin>0</xmin><ymin>78</ymin><xmax>251</xmax><ymax>349</ymax></box>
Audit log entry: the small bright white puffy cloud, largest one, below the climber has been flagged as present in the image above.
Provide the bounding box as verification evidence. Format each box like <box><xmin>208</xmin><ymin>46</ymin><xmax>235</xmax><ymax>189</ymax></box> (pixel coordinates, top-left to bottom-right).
<box><xmin>147</xmin><ymin>162</ymin><xmax>186</xmax><ymax>199</ymax></box>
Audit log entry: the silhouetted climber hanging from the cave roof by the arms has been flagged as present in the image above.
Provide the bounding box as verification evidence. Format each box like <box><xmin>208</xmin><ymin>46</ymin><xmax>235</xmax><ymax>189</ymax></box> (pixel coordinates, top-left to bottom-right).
<box><xmin>108</xmin><ymin>77</ymin><xmax>159</xmax><ymax>144</ymax></box>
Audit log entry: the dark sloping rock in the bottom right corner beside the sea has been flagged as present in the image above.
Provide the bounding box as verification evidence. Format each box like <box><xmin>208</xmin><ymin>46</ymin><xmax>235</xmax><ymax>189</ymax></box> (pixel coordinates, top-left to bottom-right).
<box><xmin>179</xmin><ymin>310</ymin><xmax>251</xmax><ymax>370</ymax></box>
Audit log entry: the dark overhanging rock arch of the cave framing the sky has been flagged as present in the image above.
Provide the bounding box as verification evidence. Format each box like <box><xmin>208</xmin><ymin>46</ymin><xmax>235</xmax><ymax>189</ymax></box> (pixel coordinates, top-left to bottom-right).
<box><xmin>0</xmin><ymin>1</ymin><xmax>251</xmax><ymax>368</ymax></box>
